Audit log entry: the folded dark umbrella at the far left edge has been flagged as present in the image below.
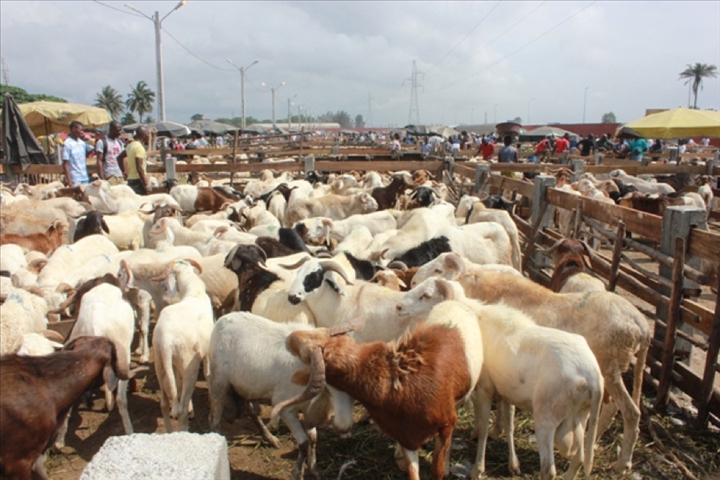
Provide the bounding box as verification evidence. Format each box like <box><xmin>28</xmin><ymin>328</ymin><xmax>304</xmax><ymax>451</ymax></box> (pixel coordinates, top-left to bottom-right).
<box><xmin>2</xmin><ymin>93</ymin><xmax>50</xmax><ymax>170</ymax></box>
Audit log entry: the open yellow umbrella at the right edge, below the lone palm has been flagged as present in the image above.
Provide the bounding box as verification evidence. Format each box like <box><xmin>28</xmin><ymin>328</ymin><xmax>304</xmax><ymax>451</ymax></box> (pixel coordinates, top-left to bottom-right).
<box><xmin>625</xmin><ymin>108</ymin><xmax>720</xmax><ymax>138</ymax></box>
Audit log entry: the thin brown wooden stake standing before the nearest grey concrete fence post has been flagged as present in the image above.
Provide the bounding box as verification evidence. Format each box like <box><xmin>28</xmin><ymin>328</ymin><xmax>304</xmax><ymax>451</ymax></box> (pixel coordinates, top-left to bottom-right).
<box><xmin>655</xmin><ymin>237</ymin><xmax>685</xmax><ymax>410</ymax></box>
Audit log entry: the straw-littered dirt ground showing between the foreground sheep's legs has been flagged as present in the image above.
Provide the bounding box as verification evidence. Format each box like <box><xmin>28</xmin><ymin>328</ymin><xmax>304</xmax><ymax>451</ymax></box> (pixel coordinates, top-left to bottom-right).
<box><xmin>47</xmin><ymin>238</ymin><xmax>720</xmax><ymax>480</ymax></box>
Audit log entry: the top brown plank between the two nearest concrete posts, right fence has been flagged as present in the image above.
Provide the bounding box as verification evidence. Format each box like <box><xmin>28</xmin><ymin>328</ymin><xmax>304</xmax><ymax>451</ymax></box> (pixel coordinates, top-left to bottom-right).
<box><xmin>547</xmin><ymin>188</ymin><xmax>662</xmax><ymax>242</ymax></box>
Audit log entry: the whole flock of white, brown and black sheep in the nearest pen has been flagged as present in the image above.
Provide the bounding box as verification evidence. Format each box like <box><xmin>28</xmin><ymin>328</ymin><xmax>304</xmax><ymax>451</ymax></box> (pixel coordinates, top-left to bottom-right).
<box><xmin>0</xmin><ymin>166</ymin><xmax>696</xmax><ymax>479</ymax></box>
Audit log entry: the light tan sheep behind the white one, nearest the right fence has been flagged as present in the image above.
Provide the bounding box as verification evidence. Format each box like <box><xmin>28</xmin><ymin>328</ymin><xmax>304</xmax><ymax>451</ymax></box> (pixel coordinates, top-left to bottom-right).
<box><xmin>412</xmin><ymin>253</ymin><xmax>650</xmax><ymax>473</ymax></box>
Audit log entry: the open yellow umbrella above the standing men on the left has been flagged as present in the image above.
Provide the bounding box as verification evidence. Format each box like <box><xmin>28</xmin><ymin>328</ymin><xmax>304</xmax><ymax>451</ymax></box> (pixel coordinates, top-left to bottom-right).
<box><xmin>18</xmin><ymin>101</ymin><xmax>112</xmax><ymax>136</ymax></box>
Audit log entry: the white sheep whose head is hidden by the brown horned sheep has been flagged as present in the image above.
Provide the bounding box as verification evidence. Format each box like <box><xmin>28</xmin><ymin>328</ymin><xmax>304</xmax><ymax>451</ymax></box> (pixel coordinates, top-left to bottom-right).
<box><xmin>208</xmin><ymin>312</ymin><xmax>353</xmax><ymax>480</ymax></box>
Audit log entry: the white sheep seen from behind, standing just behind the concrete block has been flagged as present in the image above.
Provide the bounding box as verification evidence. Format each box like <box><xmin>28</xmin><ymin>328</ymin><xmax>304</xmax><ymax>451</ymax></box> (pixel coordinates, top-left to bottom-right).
<box><xmin>152</xmin><ymin>261</ymin><xmax>213</xmax><ymax>433</ymax></box>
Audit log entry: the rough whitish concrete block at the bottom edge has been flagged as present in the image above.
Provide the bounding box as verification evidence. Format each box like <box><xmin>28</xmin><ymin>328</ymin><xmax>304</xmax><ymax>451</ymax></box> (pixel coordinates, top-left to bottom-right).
<box><xmin>80</xmin><ymin>432</ymin><xmax>230</xmax><ymax>480</ymax></box>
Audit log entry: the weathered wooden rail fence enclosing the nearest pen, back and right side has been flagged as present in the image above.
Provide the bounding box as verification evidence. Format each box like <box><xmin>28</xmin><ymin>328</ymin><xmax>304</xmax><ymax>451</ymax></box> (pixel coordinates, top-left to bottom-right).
<box><xmin>0</xmin><ymin>148</ymin><xmax>720</xmax><ymax>426</ymax></box>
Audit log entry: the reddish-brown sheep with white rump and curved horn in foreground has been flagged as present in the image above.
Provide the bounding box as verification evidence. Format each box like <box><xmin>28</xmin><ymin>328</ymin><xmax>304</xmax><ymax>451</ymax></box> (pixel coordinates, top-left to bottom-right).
<box><xmin>272</xmin><ymin>302</ymin><xmax>483</xmax><ymax>480</ymax></box>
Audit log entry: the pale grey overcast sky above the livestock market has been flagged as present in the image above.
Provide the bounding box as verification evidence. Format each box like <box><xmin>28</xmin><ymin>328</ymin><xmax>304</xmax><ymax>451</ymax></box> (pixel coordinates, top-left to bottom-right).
<box><xmin>0</xmin><ymin>0</ymin><xmax>720</xmax><ymax>127</ymax></box>
